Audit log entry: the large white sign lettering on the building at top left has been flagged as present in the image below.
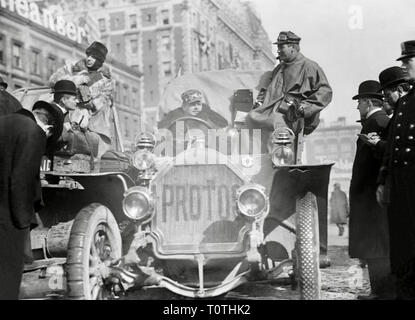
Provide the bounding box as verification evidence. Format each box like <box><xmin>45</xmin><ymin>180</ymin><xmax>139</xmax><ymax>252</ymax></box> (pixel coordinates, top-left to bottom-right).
<box><xmin>0</xmin><ymin>0</ymin><xmax>87</xmax><ymax>44</ymax></box>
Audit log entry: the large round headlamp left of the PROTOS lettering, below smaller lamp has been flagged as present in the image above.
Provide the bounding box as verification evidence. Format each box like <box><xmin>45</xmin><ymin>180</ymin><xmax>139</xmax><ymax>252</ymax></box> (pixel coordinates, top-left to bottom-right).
<box><xmin>122</xmin><ymin>187</ymin><xmax>154</xmax><ymax>221</ymax></box>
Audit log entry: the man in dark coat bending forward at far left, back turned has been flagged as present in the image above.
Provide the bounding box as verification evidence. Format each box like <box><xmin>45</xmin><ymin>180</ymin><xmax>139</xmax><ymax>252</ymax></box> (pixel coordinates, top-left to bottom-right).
<box><xmin>0</xmin><ymin>101</ymin><xmax>63</xmax><ymax>300</ymax></box>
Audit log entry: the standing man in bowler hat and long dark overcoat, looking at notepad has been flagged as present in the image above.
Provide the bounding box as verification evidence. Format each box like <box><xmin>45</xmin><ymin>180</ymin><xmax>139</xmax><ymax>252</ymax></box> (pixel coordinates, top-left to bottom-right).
<box><xmin>349</xmin><ymin>80</ymin><xmax>390</xmax><ymax>299</ymax></box>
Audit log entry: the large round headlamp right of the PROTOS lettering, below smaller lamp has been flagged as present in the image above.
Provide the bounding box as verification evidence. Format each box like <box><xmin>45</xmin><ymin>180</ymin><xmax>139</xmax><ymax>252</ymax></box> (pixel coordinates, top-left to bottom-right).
<box><xmin>237</xmin><ymin>184</ymin><xmax>269</xmax><ymax>219</ymax></box>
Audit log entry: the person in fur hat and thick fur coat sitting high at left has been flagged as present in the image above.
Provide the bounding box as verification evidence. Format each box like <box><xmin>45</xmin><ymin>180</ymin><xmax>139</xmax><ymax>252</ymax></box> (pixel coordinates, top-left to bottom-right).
<box><xmin>49</xmin><ymin>41</ymin><xmax>115</xmax><ymax>158</ymax></box>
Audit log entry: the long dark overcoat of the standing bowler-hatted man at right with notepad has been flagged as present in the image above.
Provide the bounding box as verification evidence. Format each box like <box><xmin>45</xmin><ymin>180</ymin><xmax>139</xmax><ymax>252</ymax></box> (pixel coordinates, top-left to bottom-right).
<box><xmin>349</xmin><ymin>110</ymin><xmax>390</xmax><ymax>259</ymax></box>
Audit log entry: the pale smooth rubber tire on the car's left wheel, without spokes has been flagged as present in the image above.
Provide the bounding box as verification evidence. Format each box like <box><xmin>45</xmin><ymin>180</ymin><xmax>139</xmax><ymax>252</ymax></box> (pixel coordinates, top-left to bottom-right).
<box><xmin>67</xmin><ymin>203</ymin><xmax>122</xmax><ymax>300</ymax></box>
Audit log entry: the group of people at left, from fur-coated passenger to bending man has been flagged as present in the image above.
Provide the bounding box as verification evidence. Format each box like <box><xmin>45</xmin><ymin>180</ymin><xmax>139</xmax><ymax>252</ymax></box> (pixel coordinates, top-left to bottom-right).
<box><xmin>0</xmin><ymin>42</ymin><xmax>115</xmax><ymax>300</ymax></box>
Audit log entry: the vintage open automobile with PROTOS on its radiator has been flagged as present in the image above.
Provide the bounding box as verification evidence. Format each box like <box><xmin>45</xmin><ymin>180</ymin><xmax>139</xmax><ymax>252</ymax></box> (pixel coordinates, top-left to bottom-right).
<box><xmin>14</xmin><ymin>70</ymin><xmax>331</xmax><ymax>300</ymax></box>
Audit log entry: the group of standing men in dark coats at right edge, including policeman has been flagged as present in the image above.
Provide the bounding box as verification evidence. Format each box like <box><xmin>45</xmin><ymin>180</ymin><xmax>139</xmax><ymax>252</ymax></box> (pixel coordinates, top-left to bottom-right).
<box><xmin>349</xmin><ymin>41</ymin><xmax>415</xmax><ymax>300</ymax></box>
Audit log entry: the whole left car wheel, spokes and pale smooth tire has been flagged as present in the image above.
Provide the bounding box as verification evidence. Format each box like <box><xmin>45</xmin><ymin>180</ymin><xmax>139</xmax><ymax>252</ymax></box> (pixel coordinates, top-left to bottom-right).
<box><xmin>67</xmin><ymin>204</ymin><xmax>122</xmax><ymax>300</ymax></box>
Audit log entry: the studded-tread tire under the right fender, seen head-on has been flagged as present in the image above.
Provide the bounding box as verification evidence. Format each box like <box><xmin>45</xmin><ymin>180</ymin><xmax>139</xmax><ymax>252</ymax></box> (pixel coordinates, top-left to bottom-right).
<box><xmin>295</xmin><ymin>192</ymin><xmax>321</xmax><ymax>300</ymax></box>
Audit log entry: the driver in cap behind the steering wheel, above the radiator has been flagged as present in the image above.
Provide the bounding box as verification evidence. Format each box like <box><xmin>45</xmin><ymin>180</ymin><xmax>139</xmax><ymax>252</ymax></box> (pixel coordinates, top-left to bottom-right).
<box><xmin>158</xmin><ymin>89</ymin><xmax>228</xmax><ymax>131</ymax></box>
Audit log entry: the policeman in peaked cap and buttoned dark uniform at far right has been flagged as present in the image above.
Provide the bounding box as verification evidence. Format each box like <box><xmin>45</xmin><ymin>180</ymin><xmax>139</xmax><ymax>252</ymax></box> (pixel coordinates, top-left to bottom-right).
<box><xmin>377</xmin><ymin>40</ymin><xmax>415</xmax><ymax>299</ymax></box>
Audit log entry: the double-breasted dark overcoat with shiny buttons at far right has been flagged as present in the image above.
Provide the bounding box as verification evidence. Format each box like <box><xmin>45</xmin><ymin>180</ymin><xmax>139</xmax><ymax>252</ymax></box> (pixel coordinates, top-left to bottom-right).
<box><xmin>379</xmin><ymin>89</ymin><xmax>415</xmax><ymax>274</ymax></box>
